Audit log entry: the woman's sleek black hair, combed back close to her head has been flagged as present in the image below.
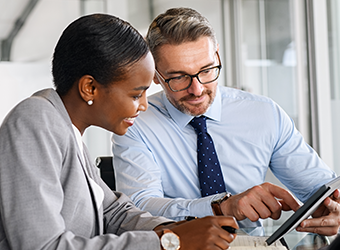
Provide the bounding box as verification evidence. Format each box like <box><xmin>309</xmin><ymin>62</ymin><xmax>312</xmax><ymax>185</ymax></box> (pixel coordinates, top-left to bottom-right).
<box><xmin>52</xmin><ymin>14</ymin><xmax>149</xmax><ymax>95</ymax></box>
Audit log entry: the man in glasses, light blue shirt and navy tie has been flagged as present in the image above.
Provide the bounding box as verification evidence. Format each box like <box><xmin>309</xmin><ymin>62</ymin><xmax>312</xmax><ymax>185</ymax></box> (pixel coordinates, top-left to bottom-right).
<box><xmin>113</xmin><ymin>8</ymin><xmax>340</xmax><ymax>234</ymax></box>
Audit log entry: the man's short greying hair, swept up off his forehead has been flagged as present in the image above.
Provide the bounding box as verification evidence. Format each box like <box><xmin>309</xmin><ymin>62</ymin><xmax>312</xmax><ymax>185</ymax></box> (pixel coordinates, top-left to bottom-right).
<box><xmin>146</xmin><ymin>8</ymin><xmax>217</xmax><ymax>61</ymax></box>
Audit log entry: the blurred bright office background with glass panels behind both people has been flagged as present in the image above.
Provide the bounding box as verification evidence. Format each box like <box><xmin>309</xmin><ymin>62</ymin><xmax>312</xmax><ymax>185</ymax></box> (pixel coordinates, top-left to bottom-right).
<box><xmin>0</xmin><ymin>0</ymin><xmax>340</xmax><ymax>229</ymax></box>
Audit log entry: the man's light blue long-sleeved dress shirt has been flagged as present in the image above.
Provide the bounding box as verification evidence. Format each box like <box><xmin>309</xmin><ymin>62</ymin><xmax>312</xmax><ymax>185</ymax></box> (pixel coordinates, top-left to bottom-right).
<box><xmin>112</xmin><ymin>86</ymin><xmax>335</xmax><ymax>226</ymax></box>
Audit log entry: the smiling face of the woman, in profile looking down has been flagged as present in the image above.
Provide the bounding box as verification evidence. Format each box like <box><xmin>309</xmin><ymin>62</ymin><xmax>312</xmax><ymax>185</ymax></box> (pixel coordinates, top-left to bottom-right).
<box><xmin>93</xmin><ymin>52</ymin><xmax>155</xmax><ymax>135</ymax></box>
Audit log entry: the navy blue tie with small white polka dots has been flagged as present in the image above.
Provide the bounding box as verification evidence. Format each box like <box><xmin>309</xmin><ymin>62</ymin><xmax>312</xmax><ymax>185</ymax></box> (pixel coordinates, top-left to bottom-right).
<box><xmin>189</xmin><ymin>116</ymin><xmax>226</xmax><ymax>197</ymax></box>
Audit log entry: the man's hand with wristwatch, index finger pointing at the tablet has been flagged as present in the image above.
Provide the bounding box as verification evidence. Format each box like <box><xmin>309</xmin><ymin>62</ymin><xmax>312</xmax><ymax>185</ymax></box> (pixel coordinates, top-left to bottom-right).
<box><xmin>221</xmin><ymin>183</ymin><xmax>300</xmax><ymax>221</ymax></box>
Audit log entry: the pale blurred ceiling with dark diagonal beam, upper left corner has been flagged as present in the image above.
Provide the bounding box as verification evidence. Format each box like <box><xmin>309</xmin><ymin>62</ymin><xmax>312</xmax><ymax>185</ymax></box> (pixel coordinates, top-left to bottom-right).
<box><xmin>0</xmin><ymin>0</ymin><xmax>80</xmax><ymax>62</ymax></box>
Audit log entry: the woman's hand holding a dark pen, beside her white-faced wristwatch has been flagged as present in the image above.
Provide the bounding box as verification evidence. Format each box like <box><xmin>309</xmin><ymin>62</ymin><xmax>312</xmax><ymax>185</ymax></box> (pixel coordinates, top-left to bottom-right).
<box><xmin>154</xmin><ymin>216</ymin><xmax>238</xmax><ymax>250</ymax></box>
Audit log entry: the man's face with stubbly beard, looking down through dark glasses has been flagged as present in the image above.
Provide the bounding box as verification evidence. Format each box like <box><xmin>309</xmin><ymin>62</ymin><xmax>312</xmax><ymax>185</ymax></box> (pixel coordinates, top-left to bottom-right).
<box><xmin>154</xmin><ymin>37</ymin><xmax>219</xmax><ymax>116</ymax></box>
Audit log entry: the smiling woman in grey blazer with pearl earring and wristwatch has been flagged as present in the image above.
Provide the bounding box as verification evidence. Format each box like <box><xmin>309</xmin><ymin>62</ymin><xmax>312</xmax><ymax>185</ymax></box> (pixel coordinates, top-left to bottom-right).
<box><xmin>0</xmin><ymin>14</ymin><xmax>237</xmax><ymax>250</ymax></box>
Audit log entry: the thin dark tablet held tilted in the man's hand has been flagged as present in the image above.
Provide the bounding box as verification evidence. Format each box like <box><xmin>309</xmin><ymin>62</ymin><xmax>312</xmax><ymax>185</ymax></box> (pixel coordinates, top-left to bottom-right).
<box><xmin>266</xmin><ymin>176</ymin><xmax>340</xmax><ymax>245</ymax></box>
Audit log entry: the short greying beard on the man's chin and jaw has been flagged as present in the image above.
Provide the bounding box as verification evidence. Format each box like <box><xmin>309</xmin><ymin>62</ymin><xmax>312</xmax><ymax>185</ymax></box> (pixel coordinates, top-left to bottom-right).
<box><xmin>167</xmin><ymin>89</ymin><xmax>216</xmax><ymax>116</ymax></box>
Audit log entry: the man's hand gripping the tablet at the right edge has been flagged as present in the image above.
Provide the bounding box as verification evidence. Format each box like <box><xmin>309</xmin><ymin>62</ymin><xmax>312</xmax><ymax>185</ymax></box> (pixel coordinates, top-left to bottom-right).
<box><xmin>296</xmin><ymin>189</ymin><xmax>340</xmax><ymax>235</ymax></box>
